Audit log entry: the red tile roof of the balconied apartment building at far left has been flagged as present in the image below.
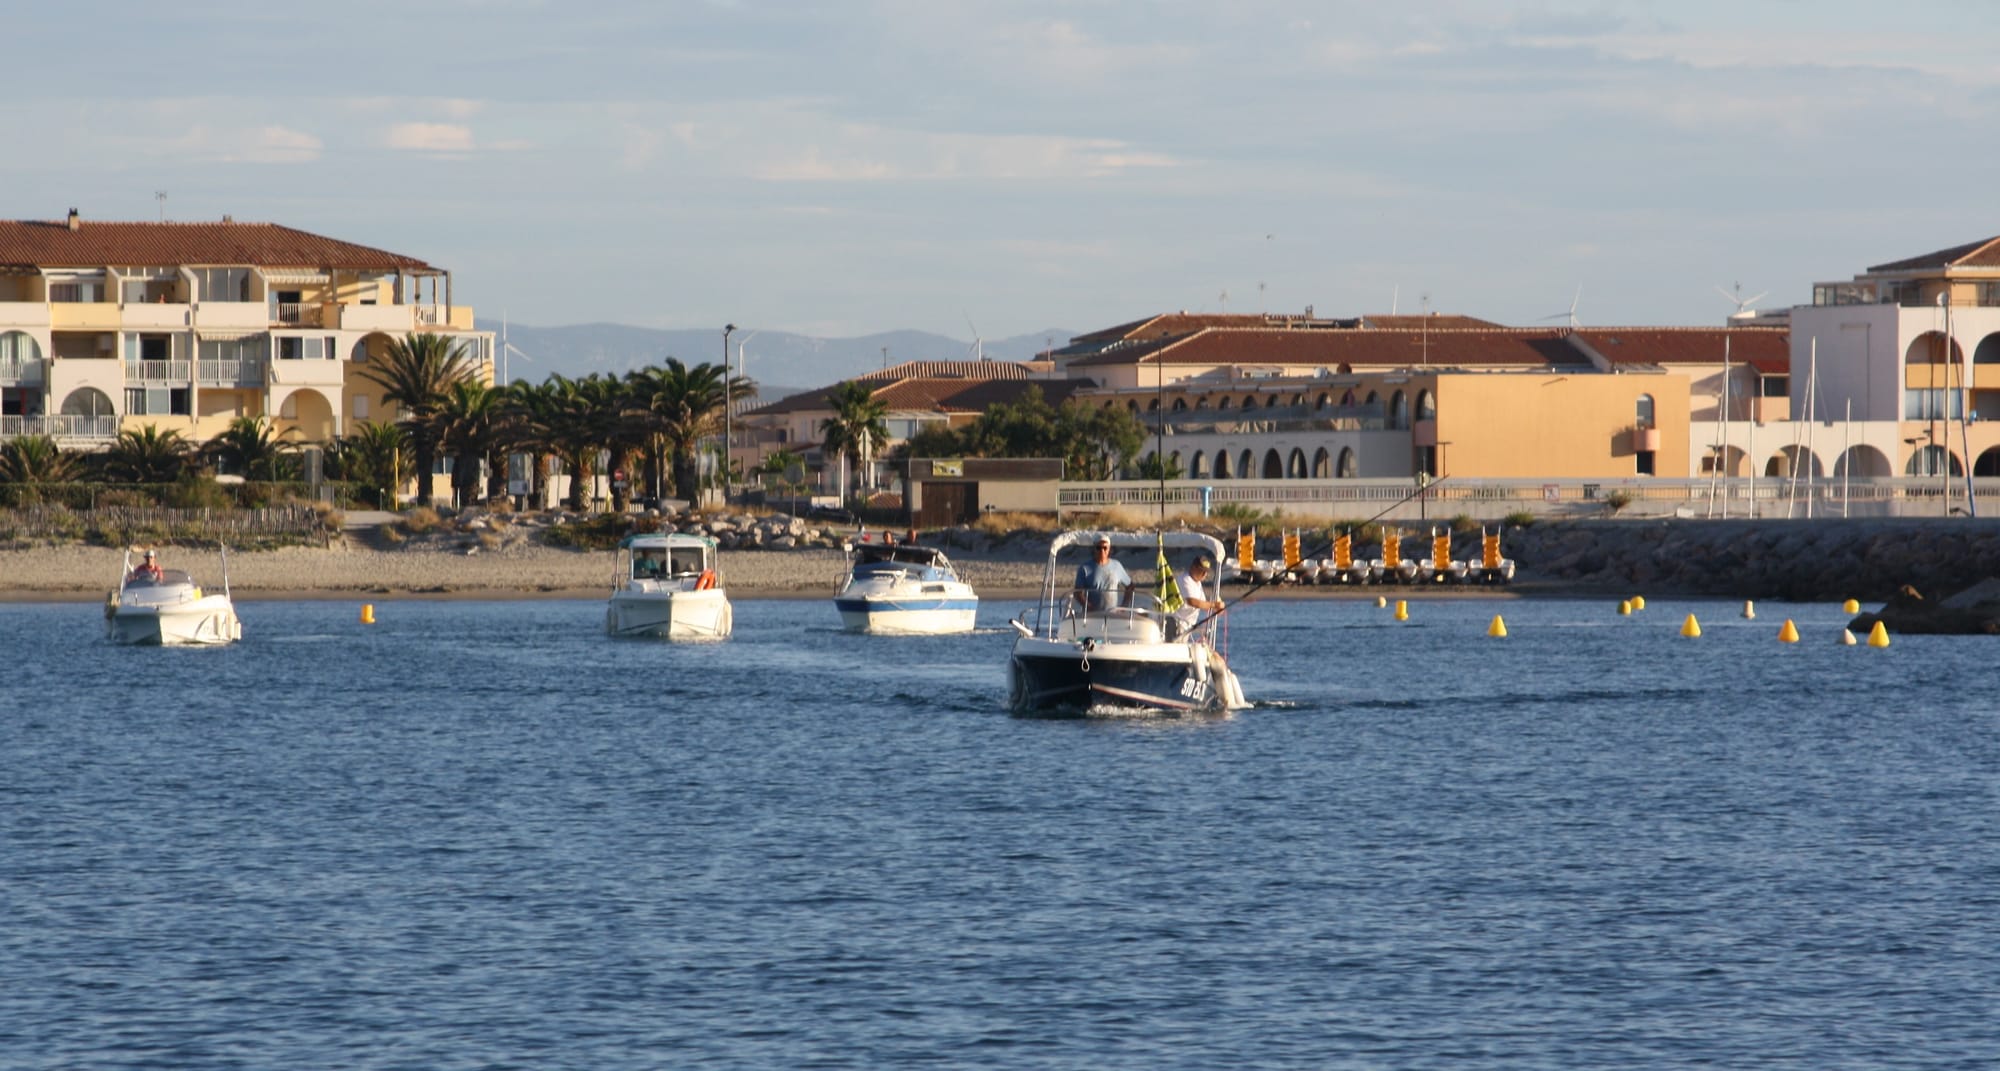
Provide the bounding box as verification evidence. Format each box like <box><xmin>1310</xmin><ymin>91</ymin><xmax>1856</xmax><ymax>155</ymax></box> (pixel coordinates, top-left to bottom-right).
<box><xmin>0</xmin><ymin>220</ymin><xmax>434</xmax><ymax>272</ymax></box>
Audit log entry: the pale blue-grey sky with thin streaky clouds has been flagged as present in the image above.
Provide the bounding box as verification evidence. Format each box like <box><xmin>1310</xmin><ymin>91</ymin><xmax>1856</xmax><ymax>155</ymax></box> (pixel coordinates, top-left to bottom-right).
<box><xmin>0</xmin><ymin>0</ymin><xmax>2000</xmax><ymax>340</ymax></box>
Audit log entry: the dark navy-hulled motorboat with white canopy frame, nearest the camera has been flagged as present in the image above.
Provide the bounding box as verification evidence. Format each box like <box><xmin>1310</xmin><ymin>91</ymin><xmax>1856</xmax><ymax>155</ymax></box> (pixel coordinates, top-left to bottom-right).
<box><xmin>1008</xmin><ymin>532</ymin><xmax>1250</xmax><ymax>713</ymax></box>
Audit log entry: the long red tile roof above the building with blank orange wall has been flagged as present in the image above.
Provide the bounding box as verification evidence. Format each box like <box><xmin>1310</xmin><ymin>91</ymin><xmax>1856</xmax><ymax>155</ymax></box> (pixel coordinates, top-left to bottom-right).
<box><xmin>1070</xmin><ymin>328</ymin><xmax>1588</xmax><ymax>368</ymax></box>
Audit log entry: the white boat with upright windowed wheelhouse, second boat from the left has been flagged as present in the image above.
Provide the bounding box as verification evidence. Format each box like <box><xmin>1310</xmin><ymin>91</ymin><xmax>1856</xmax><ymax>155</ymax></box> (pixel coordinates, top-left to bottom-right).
<box><xmin>604</xmin><ymin>532</ymin><xmax>734</xmax><ymax>639</ymax></box>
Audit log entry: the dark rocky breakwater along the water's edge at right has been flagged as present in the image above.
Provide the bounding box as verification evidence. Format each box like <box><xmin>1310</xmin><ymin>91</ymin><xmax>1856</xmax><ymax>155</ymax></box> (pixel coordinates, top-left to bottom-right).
<box><xmin>1496</xmin><ymin>518</ymin><xmax>2000</xmax><ymax>601</ymax></box>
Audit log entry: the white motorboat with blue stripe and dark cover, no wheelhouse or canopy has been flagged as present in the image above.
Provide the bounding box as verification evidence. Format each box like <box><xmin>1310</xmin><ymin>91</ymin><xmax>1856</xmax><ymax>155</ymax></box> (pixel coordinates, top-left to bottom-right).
<box><xmin>834</xmin><ymin>543</ymin><xmax>980</xmax><ymax>635</ymax></box>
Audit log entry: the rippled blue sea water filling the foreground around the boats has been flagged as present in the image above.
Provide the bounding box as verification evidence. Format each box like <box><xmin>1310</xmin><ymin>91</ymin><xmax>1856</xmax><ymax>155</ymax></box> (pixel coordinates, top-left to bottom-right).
<box><xmin>0</xmin><ymin>599</ymin><xmax>2000</xmax><ymax>1069</ymax></box>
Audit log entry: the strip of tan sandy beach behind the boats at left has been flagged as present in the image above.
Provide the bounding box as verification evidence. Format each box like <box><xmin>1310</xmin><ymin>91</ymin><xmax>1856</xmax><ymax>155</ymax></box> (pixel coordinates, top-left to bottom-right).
<box><xmin>0</xmin><ymin>545</ymin><xmax>1042</xmax><ymax>601</ymax></box>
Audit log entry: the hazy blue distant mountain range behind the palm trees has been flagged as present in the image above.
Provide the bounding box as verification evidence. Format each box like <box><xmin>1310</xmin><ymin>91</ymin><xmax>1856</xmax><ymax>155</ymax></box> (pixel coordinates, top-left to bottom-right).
<box><xmin>478</xmin><ymin>320</ymin><xmax>1076</xmax><ymax>402</ymax></box>
